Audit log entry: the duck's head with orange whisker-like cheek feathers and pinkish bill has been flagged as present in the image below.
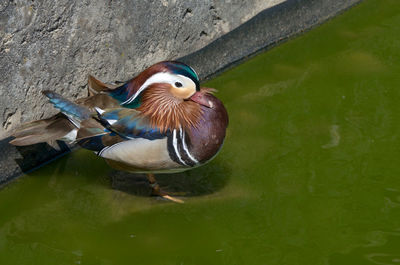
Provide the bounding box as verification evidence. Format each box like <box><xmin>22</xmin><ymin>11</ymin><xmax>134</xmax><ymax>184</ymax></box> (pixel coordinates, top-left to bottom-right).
<box><xmin>116</xmin><ymin>61</ymin><xmax>216</xmax><ymax>131</ymax></box>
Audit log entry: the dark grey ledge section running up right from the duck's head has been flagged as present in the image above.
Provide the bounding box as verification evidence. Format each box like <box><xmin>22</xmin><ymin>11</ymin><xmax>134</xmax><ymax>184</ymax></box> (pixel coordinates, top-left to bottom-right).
<box><xmin>180</xmin><ymin>0</ymin><xmax>361</xmax><ymax>80</ymax></box>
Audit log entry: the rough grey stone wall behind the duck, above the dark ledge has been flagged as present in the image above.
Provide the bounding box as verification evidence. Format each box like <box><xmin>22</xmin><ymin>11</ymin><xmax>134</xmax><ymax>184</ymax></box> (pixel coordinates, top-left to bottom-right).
<box><xmin>0</xmin><ymin>0</ymin><xmax>283</xmax><ymax>136</ymax></box>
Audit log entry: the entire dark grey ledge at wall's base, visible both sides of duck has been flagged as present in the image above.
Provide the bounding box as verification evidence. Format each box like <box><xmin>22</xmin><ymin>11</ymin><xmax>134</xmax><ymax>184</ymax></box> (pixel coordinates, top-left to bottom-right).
<box><xmin>0</xmin><ymin>0</ymin><xmax>361</xmax><ymax>185</ymax></box>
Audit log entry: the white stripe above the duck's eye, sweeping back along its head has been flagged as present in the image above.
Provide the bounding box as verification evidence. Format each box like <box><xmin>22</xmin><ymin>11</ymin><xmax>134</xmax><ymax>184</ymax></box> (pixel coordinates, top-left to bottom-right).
<box><xmin>121</xmin><ymin>72</ymin><xmax>194</xmax><ymax>105</ymax></box>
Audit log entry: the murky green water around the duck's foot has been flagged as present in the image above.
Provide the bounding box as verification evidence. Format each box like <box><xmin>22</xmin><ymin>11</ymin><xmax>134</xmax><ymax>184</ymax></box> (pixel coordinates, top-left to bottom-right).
<box><xmin>0</xmin><ymin>0</ymin><xmax>400</xmax><ymax>265</ymax></box>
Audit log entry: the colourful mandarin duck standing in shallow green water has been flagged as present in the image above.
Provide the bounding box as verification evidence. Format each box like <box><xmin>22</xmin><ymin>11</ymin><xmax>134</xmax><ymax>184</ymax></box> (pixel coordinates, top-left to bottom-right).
<box><xmin>10</xmin><ymin>61</ymin><xmax>228</xmax><ymax>202</ymax></box>
